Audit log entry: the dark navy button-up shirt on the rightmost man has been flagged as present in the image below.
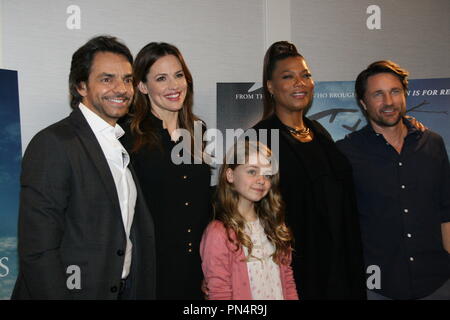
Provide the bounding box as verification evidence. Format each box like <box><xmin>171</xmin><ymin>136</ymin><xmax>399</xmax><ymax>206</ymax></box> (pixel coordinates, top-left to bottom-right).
<box><xmin>337</xmin><ymin>121</ymin><xmax>450</xmax><ymax>299</ymax></box>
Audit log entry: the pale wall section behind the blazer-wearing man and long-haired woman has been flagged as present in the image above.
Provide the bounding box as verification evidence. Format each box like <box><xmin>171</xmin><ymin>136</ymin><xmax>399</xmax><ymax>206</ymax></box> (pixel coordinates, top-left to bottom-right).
<box><xmin>3</xmin><ymin>0</ymin><xmax>264</xmax><ymax>149</ymax></box>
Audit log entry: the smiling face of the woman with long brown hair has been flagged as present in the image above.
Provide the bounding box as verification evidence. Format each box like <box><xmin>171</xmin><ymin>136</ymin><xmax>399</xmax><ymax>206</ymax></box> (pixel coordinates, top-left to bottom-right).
<box><xmin>138</xmin><ymin>55</ymin><xmax>188</xmax><ymax>115</ymax></box>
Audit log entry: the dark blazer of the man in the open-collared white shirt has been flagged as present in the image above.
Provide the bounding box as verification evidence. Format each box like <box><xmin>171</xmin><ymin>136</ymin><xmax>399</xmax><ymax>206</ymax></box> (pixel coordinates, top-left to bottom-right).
<box><xmin>12</xmin><ymin>108</ymin><xmax>155</xmax><ymax>299</ymax></box>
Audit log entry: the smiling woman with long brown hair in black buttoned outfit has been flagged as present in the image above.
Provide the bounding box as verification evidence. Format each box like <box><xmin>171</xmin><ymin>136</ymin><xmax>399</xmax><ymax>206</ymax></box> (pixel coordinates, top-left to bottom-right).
<box><xmin>119</xmin><ymin>42</ymin><xmax>211</xmax><ymax>300</ymax></box>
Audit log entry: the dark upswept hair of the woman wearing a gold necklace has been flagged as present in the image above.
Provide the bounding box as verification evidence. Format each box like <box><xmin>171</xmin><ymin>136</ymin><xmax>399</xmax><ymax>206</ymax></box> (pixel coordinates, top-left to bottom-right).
<box><xmin>263</xmin><ymin>41</ymin><xmax>303</xmax><ymax>119</ymax></box>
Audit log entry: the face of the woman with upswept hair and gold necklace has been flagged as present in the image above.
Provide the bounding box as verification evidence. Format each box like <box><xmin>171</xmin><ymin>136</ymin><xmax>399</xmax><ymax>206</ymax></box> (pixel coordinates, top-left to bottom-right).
<box><xmin>267</xmin><ymin>57</ymin><xmax>314</xmax><ymax>117</ymax></box>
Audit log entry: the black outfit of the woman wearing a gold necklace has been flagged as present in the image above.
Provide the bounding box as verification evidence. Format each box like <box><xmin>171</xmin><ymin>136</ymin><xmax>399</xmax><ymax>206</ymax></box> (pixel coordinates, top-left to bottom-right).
<box><xmin>254</xmin><ymin>115</ymin><xmax>365</xmax><ymax>299</ymax></box>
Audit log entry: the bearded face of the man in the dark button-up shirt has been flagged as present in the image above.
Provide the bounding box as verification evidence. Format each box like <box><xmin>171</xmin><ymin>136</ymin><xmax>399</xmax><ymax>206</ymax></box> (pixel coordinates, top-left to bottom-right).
<box><xmin>360</xmin><ymin>73</ymin><xmax>406</xmax><ymax>127</ymax></box>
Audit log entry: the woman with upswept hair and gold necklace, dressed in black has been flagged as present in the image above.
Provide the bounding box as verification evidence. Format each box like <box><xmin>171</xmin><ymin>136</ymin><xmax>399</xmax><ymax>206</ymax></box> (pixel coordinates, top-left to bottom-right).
<box><xmin>254</xmin><ymin>41</ymin><xmax>365</xmax><ymax>299</ymax></box>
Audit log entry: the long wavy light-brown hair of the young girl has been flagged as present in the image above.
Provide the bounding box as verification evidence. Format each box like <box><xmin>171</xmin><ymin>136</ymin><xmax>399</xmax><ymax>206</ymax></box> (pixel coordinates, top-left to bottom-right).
<box><xmin>214</xmin><ymin>141</ymin><xmax>293</xmax><ymax>264</ymax></box>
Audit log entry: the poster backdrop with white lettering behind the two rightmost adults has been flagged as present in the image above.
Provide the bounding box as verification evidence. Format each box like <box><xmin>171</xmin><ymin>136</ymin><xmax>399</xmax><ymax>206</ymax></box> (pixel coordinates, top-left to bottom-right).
<box><xmin>217</xmin><ymin>78</ymin><xmax>450</xmax><ymax>154</ymax></box>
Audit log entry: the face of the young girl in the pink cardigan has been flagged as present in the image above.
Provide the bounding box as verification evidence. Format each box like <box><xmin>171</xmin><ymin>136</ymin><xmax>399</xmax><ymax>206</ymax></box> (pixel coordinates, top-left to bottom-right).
<box><xmin>226</xmin><ymin>153</ymin><xmax>273</xmax><ymax>203</ymax></box>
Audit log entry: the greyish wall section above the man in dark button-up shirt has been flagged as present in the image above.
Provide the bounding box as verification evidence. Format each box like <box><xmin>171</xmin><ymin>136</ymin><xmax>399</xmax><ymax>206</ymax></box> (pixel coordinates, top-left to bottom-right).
<box><xmin>291</xmin><ymin>0</ymin><xmax>450</xmax><ymax>81</ymax></box>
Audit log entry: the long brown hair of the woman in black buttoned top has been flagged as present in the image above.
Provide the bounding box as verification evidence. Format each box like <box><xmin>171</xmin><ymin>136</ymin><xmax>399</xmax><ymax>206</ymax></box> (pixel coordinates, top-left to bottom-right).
<box><xmin>130</xmin><ymin>42</ymin><xmax>203</xmax><ymax>152</ymax></box>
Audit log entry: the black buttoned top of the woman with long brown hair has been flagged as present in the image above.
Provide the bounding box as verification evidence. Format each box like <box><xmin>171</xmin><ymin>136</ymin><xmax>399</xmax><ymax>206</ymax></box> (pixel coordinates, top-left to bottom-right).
<box><xmin>119</xmin><ymin>114</ymin><xmax>212</xmax><ymax>300</ymax></box>
